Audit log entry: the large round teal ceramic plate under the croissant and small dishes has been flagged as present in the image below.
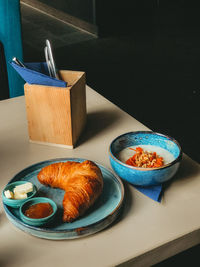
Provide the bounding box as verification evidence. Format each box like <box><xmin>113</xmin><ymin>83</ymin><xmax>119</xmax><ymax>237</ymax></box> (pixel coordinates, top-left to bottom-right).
<box><xmin>4</xmin><ymin>158</ymin><xmax>124</xmax><ymax>240</ymax></box>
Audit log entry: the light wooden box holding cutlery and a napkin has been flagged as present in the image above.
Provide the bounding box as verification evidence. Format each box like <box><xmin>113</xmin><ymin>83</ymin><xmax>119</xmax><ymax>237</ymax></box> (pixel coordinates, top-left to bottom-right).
<box><xmin>24</xmin><ymin>70</ymin><xmax>86</xmax><ymax>148</ymax></box>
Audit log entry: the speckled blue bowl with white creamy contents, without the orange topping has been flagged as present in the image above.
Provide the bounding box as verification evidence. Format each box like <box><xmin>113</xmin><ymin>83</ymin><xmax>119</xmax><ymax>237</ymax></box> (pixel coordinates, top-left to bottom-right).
<box><xmin>109</xmin><ymin>131</ymin><xmax>182</xmax><ymax>186</ymax></box>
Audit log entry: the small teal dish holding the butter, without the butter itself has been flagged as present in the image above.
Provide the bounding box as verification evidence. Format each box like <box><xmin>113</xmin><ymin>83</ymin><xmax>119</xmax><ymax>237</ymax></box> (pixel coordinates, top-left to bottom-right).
<box><xmin>2</xmin><ymin>181</ymin><xmax>37</xmax><ymax>208</ymax></box>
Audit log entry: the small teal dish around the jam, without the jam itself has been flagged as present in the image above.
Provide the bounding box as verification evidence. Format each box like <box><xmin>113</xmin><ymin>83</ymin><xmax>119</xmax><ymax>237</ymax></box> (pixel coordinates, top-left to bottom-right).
<box><xmin>19</xmin><ymin>197</ymin><xmax>57</xmax><ymax>226</ymax></box>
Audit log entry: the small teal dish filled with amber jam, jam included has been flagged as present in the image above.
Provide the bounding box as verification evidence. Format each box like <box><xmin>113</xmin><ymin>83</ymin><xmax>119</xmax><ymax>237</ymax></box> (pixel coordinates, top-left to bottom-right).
<box><xmin>20</xmin><ymin>197</ymin><xmax>57</xmax><ymax>226</ymax></box>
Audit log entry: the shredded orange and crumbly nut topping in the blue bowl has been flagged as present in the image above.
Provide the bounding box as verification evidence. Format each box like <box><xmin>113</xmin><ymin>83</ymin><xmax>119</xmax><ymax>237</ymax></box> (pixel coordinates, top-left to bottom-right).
<box><xmin>126</xmin><ymin>147</ymin><xmax>164</xmax><ymax>168</ymax></box>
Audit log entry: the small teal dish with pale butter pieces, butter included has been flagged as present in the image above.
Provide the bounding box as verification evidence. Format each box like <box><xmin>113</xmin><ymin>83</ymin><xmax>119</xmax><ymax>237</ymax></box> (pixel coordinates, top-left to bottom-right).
<box><xmin>2</xmin><ymin>181</ymin><xmax>37</xmax><ymax>208</ymax></box>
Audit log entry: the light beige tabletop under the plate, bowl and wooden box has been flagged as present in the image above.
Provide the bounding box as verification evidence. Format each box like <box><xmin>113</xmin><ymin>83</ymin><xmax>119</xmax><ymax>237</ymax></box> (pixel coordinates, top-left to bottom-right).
<box><xmin>0</xmin><ymin>87</ymin><xmax>200</xmax><ymax>267</ymax></box>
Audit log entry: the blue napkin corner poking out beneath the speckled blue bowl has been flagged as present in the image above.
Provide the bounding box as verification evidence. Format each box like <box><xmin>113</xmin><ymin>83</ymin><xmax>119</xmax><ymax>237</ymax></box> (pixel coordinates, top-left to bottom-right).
<box><xmin>134</xmin><ymin>185</ymin><xmax>162</xmax><ymax>202</ymax></box>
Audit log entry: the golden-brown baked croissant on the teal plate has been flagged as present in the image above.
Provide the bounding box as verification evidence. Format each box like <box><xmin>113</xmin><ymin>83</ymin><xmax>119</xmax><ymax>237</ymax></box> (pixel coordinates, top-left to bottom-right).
<box><xmin>37</xmin><ymin>160</ymin><xmax>103</xmax><ymax>222</ymax></box>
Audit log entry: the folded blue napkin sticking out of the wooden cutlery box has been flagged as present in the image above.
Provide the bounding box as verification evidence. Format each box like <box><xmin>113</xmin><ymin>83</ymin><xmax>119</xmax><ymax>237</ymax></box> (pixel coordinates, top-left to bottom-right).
<box><xmin>10</xmin><ymin>62</ymin><xmax>67</xmax><ymax>87</ymax></box>
